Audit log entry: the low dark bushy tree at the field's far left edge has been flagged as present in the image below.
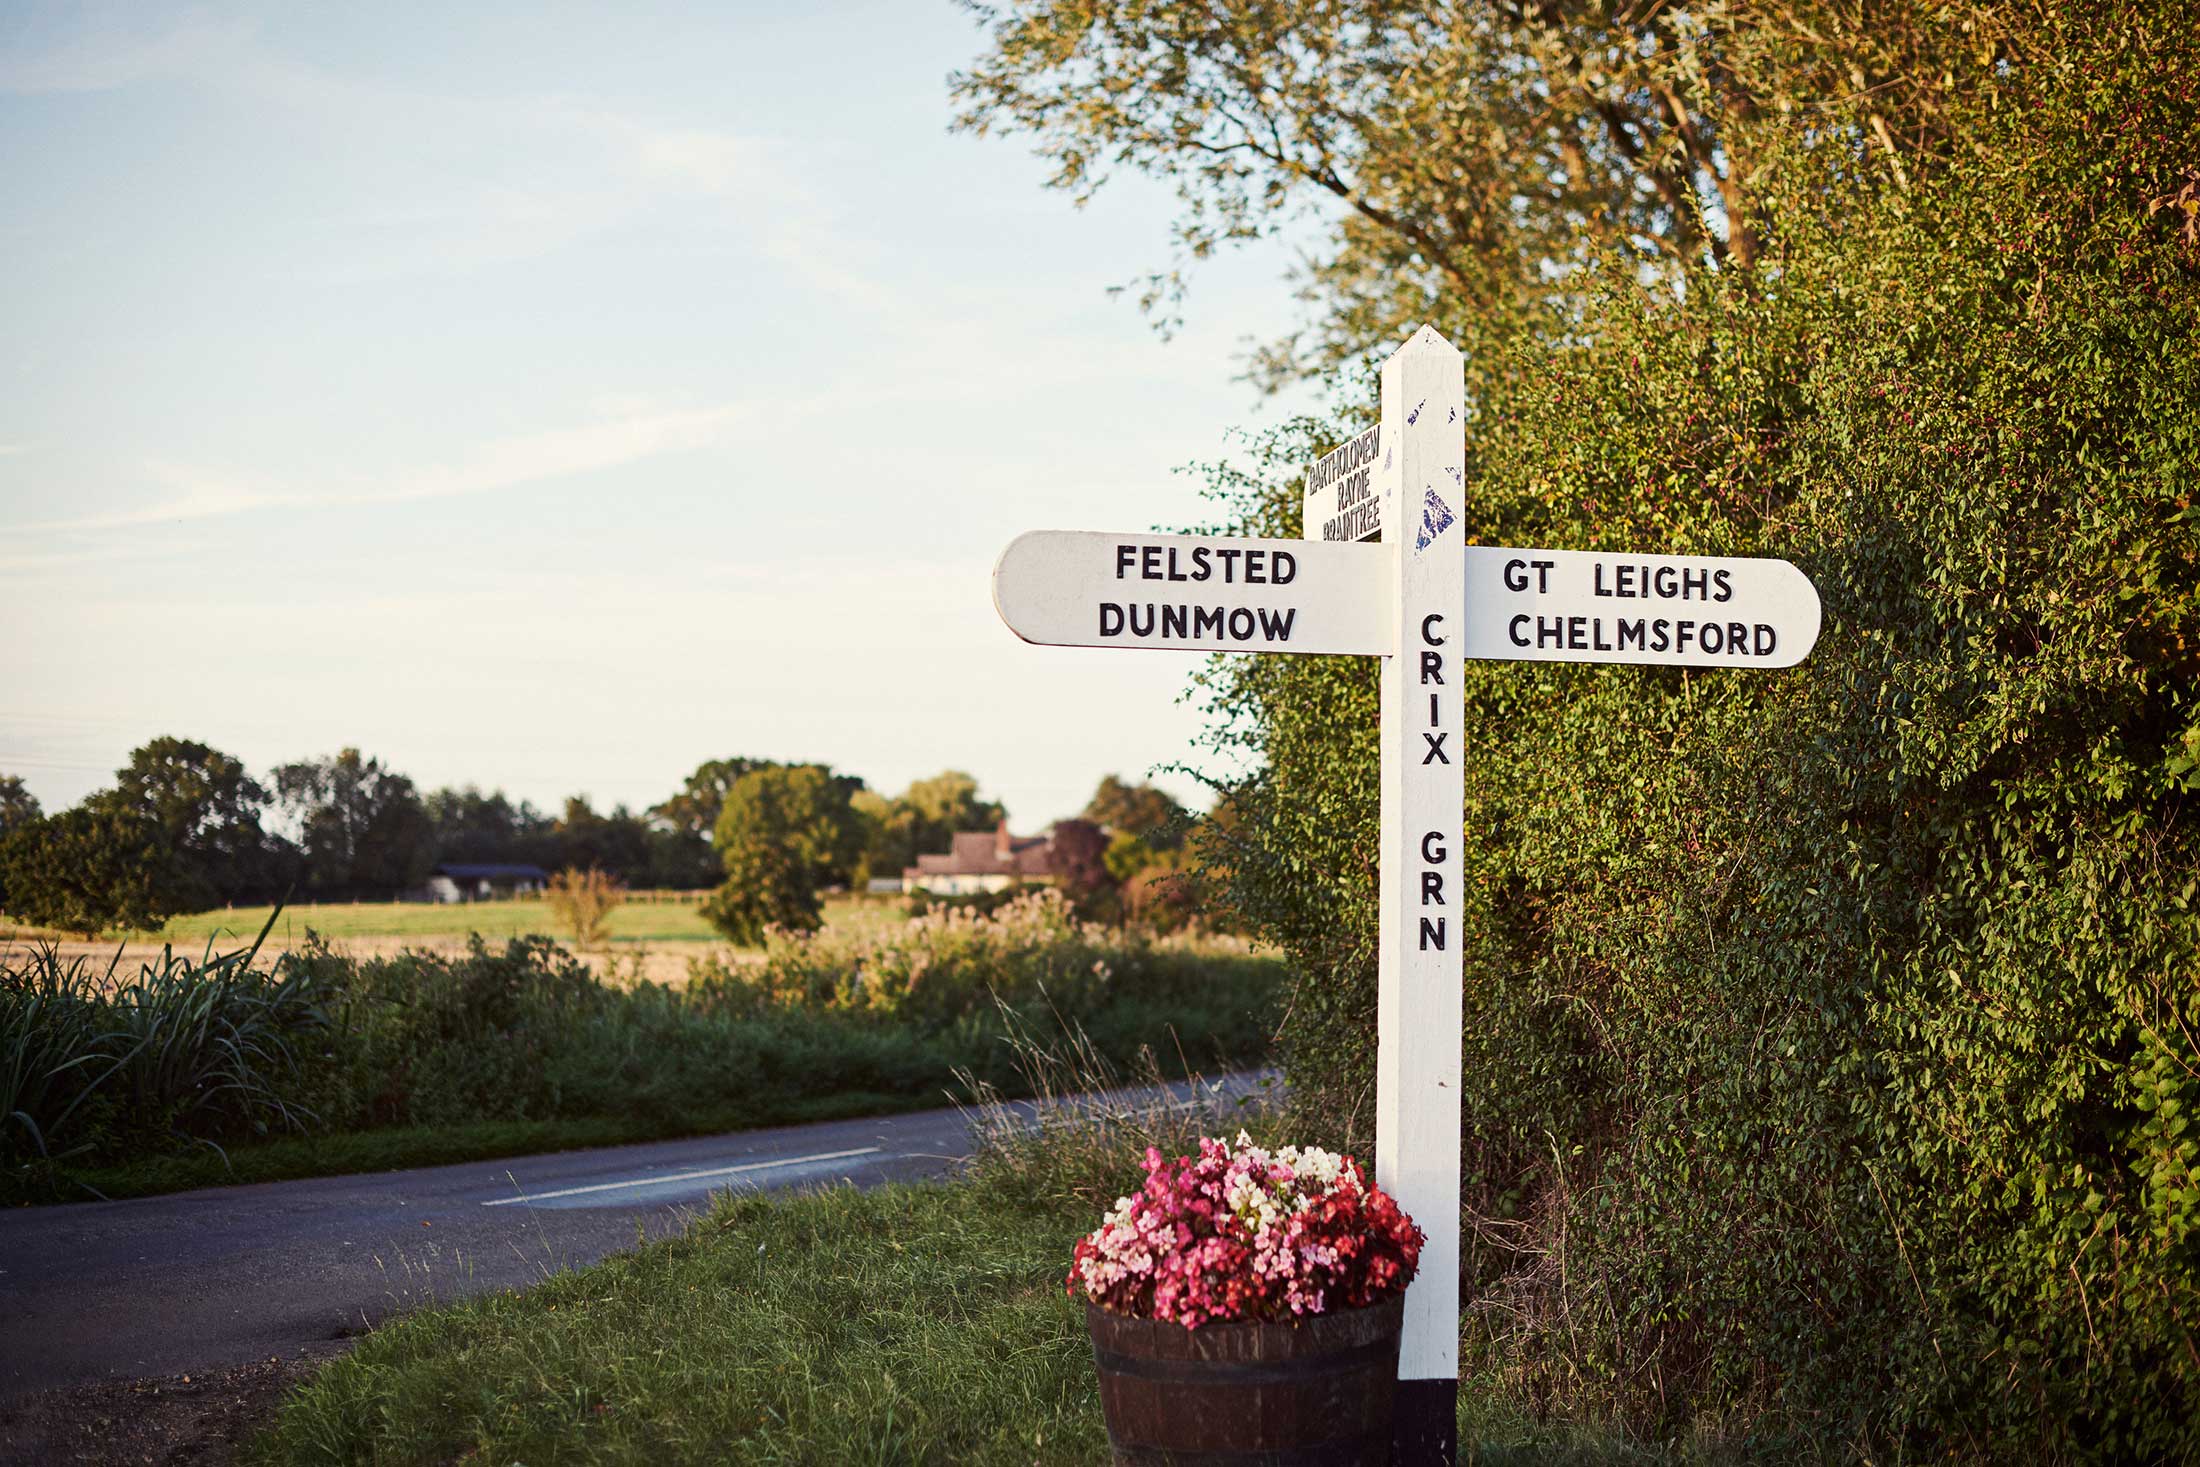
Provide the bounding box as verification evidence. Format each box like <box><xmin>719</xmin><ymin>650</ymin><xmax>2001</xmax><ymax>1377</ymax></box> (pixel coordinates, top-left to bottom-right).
<box><xmin>0</xmin><ymin>803</ymin><xmax>207</xmax><ymax>937</ymax></box>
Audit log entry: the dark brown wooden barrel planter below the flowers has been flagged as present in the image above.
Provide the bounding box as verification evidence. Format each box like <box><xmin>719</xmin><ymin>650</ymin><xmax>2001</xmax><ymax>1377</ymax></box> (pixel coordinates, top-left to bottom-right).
<box><xmin>1085</xmin><ymin>1298</ymin><xmax>1406</xmax><ymax>1467</ymax></box>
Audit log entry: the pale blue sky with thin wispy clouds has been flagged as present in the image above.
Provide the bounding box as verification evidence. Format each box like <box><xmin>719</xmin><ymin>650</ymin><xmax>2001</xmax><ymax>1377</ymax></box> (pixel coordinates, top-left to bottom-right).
<box><xmin>0</xmin><ymin>0</ymin><xmax>1307</xmax><ymax>829</ymax></box>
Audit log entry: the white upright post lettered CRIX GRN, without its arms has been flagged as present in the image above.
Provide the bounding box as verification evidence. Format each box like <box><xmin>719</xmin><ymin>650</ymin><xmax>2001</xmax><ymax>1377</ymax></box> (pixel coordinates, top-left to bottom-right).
<box><xmin>1375</xmin><ymin>326</ymin><xmax>1465</xmax><ymax>1467</ymax></box>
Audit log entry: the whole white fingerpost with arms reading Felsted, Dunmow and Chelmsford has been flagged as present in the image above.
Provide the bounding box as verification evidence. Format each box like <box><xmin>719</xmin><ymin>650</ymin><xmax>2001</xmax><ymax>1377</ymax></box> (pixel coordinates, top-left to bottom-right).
<box><xmin>992</xmin><ymin>326</ymin><xmax>1819</xmax><ymax>1467</ymax></box>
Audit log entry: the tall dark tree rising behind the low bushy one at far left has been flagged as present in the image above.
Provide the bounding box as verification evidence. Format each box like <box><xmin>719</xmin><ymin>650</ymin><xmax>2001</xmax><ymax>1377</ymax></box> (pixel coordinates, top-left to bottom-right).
<box><xmin>88</xmin><ymin>737</ymin><xmax>295</xmax><ymax>904</ymax></box>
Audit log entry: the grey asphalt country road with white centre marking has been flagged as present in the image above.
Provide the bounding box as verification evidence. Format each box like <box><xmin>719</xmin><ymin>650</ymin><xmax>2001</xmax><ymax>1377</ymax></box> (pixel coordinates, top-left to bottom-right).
<box><xmin>0</xmin><ymin>1111</ymin><xmax>970</xmax><ymax>1401</ymax></box>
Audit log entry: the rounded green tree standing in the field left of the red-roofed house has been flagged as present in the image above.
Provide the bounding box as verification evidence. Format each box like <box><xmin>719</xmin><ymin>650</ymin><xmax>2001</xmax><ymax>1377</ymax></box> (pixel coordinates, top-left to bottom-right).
<box><xmin>704</xmin><ymin>763</ymin><xmax>865</xmax><ymax>944</ymax></box>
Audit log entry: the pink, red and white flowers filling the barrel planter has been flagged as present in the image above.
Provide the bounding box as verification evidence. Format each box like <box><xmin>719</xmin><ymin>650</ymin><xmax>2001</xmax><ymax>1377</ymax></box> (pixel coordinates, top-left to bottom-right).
<box><xmin>1069</xmin><ymin>1130</ymin><xmax>1423</xmax><ymax>1328</ymax></box>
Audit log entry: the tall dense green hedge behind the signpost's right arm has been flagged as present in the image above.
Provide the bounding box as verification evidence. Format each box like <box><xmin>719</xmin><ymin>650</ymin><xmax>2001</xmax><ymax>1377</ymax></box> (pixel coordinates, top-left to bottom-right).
<box><xmin>1206</xmin><ymin>4</ymin><xmax>2200</xmax><ymax>1460</ymax></box>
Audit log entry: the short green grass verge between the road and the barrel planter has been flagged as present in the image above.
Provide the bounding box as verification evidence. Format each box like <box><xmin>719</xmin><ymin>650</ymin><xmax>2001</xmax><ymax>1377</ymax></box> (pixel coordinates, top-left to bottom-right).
<box><xmin>251</xmin><ymin>1185</ymin><xmax>1107</xmax><ymax>1465</ymax></box>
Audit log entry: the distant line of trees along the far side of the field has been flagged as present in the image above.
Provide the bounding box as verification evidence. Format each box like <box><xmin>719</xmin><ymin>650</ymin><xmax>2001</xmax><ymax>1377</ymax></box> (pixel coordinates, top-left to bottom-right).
<box><xmin>0</xmin><ymin>737</ymin><xmax>1184</xmax><ymax>941</ymax></box>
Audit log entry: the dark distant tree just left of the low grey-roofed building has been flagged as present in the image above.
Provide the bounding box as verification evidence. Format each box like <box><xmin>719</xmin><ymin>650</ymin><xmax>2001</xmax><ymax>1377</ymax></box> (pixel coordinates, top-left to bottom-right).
<box><xmin>275</xmin><ymin>748</ymin><xmax>436</xmax><ymax>895</ymax></box>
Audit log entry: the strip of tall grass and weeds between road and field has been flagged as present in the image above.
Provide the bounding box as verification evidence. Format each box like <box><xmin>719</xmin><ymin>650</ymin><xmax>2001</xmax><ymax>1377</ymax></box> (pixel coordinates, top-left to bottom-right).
<box><xmin>0</xmin><ymin>911</ymin><xmax>1280</xmax><ymax>1196</ymax></box>
